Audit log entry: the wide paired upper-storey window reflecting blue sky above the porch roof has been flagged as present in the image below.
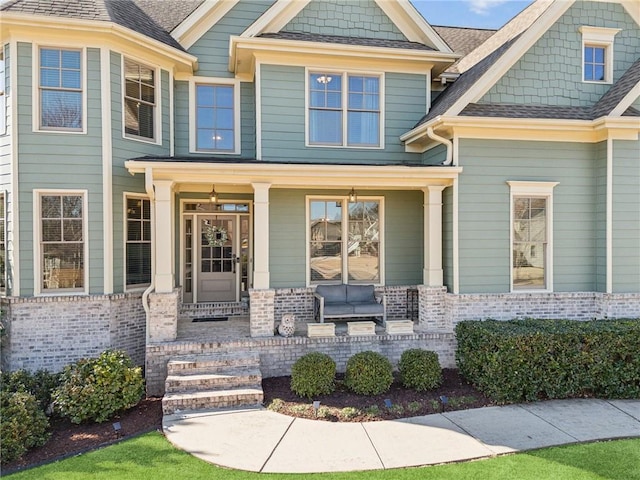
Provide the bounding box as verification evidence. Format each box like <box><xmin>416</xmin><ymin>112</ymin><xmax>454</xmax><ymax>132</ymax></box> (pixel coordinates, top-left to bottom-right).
<box><xmin>307</xmin><ymin>72</ymin><xmax>383</xmax><ymax>148</ymax></box>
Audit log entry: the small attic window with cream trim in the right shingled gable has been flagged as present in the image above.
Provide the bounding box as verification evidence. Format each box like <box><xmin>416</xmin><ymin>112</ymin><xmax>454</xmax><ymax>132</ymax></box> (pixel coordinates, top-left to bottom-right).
<box><xmin>580</xmin><ymin>26</ymin><xmax>620</xmax><ymax>83</ymax></box>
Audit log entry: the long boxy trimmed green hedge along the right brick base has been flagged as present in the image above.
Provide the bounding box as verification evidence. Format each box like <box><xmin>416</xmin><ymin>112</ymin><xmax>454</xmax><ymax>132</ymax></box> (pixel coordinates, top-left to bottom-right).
<box><xmin>456</xmin><ymin>320</ymin><xmax>640</xmax><ymax>403</ymax></box>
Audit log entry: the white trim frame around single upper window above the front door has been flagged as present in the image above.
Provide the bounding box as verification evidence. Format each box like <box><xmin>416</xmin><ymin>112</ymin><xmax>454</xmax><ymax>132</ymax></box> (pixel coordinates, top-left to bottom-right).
<box><xmin>189</xmin><ymin>77</ymin><xmax>242</xmax><ymax>155</ymax></box>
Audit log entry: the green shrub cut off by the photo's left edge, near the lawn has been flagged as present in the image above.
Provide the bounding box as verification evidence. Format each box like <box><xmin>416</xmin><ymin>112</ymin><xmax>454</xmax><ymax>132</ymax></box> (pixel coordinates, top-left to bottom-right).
<box><xmin>0</xmin><ymin>390</ymin><xmax>50</xmax><ymax>463</ymax></box>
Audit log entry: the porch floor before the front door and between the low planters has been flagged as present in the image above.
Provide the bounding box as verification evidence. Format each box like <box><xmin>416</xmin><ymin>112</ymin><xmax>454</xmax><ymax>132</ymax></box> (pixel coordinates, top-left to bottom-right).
<box><xmin>176</xmin><ymin>315</ymin><xmax>410</xmax><ymax>342</ymax></box>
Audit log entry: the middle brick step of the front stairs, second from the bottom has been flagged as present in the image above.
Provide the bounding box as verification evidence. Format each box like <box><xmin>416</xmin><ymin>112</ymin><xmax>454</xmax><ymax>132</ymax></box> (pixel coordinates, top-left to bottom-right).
<box><xmin>165</xmin><ymin>366</ymin><xmax>262</xmax><ymax>394</ymax></box>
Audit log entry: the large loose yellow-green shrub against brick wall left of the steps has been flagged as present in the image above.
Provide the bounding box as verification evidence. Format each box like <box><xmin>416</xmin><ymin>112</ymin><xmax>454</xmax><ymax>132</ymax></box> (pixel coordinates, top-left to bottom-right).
<box><xmin>53</xmin><ymin>350</ymin><xmax>144</xmax><ymax>423</ymax></box>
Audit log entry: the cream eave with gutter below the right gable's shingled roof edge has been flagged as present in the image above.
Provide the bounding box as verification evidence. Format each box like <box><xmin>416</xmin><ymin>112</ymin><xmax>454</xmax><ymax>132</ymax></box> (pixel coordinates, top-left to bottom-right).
<box><xmin>400</xmin><ymin>116</ymin><xmax>640</xmax><ymax>153</ymax></box>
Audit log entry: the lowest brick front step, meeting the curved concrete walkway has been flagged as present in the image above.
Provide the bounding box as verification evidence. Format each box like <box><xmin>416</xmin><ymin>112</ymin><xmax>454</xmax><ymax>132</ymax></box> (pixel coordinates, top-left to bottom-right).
<box><xmin>162</xmin><ymin>385</ymin><xmax>264</xmax><ymax>415</ymax></box>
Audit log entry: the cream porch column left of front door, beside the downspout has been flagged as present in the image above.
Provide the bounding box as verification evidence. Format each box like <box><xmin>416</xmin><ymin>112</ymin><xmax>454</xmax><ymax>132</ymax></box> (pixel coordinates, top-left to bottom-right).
<box><xmin>153</xmin><ymin>180</ymin><xmax>174</xmax><ymax>293</ymax></box>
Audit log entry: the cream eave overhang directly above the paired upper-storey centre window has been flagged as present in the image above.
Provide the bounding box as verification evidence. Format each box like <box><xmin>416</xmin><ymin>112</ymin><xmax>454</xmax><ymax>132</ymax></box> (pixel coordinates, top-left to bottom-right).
<box><xmin>229</xmin><ymin>36</ymin><xmax>460</xmax><ymax>81</ymax></box>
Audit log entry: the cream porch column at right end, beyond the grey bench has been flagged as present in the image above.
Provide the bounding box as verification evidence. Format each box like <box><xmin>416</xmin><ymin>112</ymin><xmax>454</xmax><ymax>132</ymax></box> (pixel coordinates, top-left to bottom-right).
<box><xmin>422</xmin><ymin>185</ymin><xmax>446</xmax><ymax>287</ymax></box>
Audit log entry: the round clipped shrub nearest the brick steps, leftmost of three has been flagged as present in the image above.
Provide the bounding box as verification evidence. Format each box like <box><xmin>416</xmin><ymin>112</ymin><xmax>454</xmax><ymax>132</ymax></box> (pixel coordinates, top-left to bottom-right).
<box><xmin>291</xmin><ymin>352</ymin><xmax>336</xmax><ymax>398</ymax></box>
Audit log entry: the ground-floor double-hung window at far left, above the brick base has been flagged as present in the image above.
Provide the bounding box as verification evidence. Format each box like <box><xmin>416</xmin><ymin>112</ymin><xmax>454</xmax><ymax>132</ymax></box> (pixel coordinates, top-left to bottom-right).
<box><xmin>38</xmin><ymin>192</ymin><xmax>86</xmax><ymax>293</ymax></box>
